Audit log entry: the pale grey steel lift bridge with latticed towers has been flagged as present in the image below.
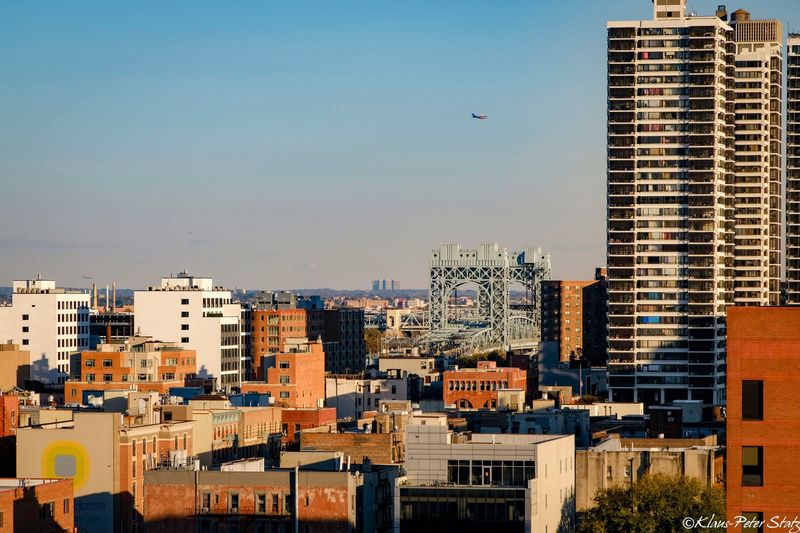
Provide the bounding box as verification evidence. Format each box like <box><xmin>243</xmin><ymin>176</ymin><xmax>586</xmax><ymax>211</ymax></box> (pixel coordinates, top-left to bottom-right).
<box><xmin>420</xmin><ymin>243</ymin><xmax>551</xmax><ymax>353</ymax></box>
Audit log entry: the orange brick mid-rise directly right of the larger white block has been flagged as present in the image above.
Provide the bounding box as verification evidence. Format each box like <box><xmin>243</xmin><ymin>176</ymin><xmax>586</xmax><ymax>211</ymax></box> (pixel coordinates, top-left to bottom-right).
<box><xmin>250</xmin><ymin>309</ymin><xmax>307</xmax><ymax>380</ymax></box>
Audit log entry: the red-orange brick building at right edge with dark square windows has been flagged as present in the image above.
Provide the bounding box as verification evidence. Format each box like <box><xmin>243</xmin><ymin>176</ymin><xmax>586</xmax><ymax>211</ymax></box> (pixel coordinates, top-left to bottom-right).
<box><xmin>727</xmin><ymin>307</ymin><xmax>800</xmax><ymax>531</ymax></box>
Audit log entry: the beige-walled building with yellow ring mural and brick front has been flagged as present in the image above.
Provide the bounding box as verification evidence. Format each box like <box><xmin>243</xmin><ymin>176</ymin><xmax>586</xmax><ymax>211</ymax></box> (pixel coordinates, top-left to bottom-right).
<box><xmin>17</xmin><ymin>412</ymin><xmax>192</xmax><ymax>533</ymax></box>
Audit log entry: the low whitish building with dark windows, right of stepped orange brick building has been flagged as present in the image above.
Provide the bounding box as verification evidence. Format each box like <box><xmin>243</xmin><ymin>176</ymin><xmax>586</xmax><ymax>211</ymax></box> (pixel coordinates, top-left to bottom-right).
<box><xmin>325</xmin><ymin>375</ymin><xmax>408</xmax><ymax>419</ymax></box>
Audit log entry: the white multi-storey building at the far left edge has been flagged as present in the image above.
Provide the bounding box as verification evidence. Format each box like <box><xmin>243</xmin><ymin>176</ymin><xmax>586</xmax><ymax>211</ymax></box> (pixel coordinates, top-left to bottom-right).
<box><xmin>0</xmin><ymin>279</ymin><xmax>90</xmax><ymax>383</ymax></box>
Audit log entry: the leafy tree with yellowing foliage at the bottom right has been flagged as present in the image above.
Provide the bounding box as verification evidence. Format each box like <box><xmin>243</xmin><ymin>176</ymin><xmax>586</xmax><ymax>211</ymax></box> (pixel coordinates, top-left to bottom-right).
<box><xmin>578</xmin><ymin>475</ymin><xmax>725</xmax><ymax>533</ymax></box>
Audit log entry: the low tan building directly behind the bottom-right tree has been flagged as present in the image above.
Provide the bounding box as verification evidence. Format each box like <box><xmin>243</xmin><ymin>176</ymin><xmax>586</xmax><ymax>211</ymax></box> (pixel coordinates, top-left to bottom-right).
<box><xmin>575</xmin><ymin>437</ymin><xmax>724</xmax><ymax>512</ymax></box>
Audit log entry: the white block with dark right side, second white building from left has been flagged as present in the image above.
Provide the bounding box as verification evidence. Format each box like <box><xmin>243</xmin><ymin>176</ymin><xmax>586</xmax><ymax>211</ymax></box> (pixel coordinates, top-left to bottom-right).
<box><xmin>133</xmin><ymin>272</ymin><xmax>245</xmax><ymax>389</ymax></box>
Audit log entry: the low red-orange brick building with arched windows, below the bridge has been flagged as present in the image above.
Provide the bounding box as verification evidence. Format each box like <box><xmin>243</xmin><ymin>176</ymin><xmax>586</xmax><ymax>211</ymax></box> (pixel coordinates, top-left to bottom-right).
<box><xmin>442</xmin><ymin>361</ymin><xmax>527</xmax><ymax>409</ymax></box>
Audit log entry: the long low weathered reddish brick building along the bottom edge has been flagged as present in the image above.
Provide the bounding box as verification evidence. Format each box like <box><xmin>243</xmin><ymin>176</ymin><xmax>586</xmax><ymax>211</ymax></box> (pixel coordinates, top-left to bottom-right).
<box><xmin>144</xmin><ymin>470</ymin><xmax>358</xmax><ymax>533</ymax></box>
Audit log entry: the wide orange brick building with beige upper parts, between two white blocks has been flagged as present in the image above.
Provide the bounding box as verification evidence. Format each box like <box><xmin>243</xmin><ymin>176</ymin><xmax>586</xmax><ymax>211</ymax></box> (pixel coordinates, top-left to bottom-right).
<box><xmin>64</xmin><ymin>337</ymin><xmax>197</xmax><ymax>405</ymax></box>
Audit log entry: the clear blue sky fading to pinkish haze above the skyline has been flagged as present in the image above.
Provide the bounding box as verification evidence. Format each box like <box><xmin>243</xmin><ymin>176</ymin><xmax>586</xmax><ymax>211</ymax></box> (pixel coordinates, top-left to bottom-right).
<box><xmin>0</xmin><ymin>0</ymin><xmax>800</xmax><ymax>288</ymax></box>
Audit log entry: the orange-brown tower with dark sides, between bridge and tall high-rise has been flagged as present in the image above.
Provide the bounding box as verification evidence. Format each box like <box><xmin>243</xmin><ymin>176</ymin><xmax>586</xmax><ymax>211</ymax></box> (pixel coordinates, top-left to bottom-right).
<box><xmin>541</xmin><ymin>268</ymin><xmax>608</xmax><ymax>365</ymax></box>
